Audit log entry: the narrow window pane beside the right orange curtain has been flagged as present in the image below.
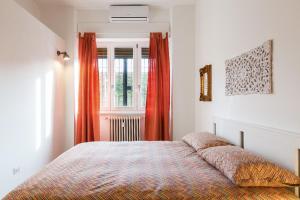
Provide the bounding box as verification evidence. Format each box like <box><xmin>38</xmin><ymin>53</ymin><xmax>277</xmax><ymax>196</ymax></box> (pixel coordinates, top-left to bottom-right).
<box><xmin>140</xmin><ymin>48</ymin><xmax>149</xmax><ymax>107</ymax></box>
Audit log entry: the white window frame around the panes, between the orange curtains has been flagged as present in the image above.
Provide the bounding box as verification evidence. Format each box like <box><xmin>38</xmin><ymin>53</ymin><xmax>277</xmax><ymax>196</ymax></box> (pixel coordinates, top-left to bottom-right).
<box><xmin>97</xmin><ymin>39</ymin><xmax>149</xmax><ymax>114</ymax></box>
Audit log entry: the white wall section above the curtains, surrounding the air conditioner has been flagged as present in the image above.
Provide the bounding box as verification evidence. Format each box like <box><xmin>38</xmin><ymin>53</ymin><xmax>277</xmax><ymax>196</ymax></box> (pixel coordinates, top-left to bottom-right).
<box><xmin>78</xmin><ymin>7</ymin><xmax>170</xmax><ymax>38</ymax></box>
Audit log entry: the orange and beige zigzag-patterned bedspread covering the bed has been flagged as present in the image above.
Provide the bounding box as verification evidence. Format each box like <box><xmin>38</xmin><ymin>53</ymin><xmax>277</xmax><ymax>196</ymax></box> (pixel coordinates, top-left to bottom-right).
<box><xmin>4</xmin><ymin>142</ymin><xmax>297</xmax><ymax>200</ymax></box>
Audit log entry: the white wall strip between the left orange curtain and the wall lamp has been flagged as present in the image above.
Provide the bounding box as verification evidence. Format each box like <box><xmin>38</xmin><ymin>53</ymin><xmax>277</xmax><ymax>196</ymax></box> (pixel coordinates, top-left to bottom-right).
<box><xmin>40</xmin><ymin>5</ymin><xmax>77</xmax><ymax>150</ymax></box>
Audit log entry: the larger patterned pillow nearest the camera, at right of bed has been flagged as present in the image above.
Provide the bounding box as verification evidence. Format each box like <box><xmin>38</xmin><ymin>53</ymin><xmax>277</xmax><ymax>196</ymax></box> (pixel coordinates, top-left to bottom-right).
<box><xmin>198</xmin><ymin>146</ymin><xmax>300</xmax><ymax>187</ymax></box>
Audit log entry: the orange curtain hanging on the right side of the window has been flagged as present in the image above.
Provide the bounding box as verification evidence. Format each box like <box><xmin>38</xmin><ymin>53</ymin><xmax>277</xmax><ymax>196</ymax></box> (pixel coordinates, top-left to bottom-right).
<box><xmin>145</xmin><ymin>33</ymin><xmax>171</xmax><ymax>141</ymax></box>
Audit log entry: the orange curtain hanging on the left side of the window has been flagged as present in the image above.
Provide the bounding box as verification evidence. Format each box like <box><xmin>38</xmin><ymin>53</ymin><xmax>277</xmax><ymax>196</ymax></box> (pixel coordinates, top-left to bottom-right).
<box><xmin>75</xmin><ymin>33</ymin><xmax>100</xmax><ymax>144</ymax></box>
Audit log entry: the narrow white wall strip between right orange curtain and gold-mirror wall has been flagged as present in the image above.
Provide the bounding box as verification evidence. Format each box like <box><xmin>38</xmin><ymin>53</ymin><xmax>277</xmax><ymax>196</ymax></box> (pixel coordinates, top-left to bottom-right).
<box><xmin>171</xmin><ymin>5</ymin><xmax>195</xmax><ymax>140</ymax></box>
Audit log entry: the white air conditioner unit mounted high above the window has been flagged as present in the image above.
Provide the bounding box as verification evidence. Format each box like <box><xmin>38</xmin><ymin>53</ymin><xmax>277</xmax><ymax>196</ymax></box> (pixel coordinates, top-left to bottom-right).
<box><xmin>109</xmin><ymin>5</ymin><xmax>149</xmax><ymax>22</ymax></box>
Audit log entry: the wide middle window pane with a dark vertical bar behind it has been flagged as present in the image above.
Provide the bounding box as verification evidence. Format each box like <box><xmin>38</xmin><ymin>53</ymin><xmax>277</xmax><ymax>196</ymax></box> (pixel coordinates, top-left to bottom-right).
<box><xmin>114</xmin><ymin>48</ymin><xmax>134</xmax><ymax>107</ymax></box>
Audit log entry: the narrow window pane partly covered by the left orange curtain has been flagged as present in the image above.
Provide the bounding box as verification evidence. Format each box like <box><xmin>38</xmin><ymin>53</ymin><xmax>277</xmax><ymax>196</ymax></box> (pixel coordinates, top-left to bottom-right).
<box><xmin>98</xmin><ymin>48</ymin><xmax>109</xmax><ymax>109</ymax></box>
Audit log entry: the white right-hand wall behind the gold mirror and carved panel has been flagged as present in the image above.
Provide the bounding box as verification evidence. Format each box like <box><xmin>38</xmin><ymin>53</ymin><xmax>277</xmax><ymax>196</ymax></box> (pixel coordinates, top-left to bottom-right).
<box><xmin>195</xmin><ymin>0</ymin><xmax>300</xmax><ymax>132</ymax></box>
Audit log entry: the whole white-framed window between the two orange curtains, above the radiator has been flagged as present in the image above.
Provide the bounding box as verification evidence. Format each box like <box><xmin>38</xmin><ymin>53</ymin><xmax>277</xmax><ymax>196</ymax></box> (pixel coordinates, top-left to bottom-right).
<box><xmin>98</xmin><ymin>42</ymin><xmax>149</xmax><ymax>113</ymax></box>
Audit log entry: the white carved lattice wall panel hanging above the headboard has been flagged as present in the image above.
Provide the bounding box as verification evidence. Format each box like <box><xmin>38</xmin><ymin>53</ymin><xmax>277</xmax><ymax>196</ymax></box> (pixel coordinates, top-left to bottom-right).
<box><xmin>225</xmin><ymin>40</ymin><xmax>272</xmax><ymax>96</ymax></box>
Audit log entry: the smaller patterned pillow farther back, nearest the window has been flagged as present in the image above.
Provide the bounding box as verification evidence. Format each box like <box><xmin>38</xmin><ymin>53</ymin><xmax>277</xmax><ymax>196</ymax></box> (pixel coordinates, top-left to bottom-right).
<box><xmin>182</xmin><ymin>132</ymin><xmax>230</xmax><ymax>151</ymax></box>
